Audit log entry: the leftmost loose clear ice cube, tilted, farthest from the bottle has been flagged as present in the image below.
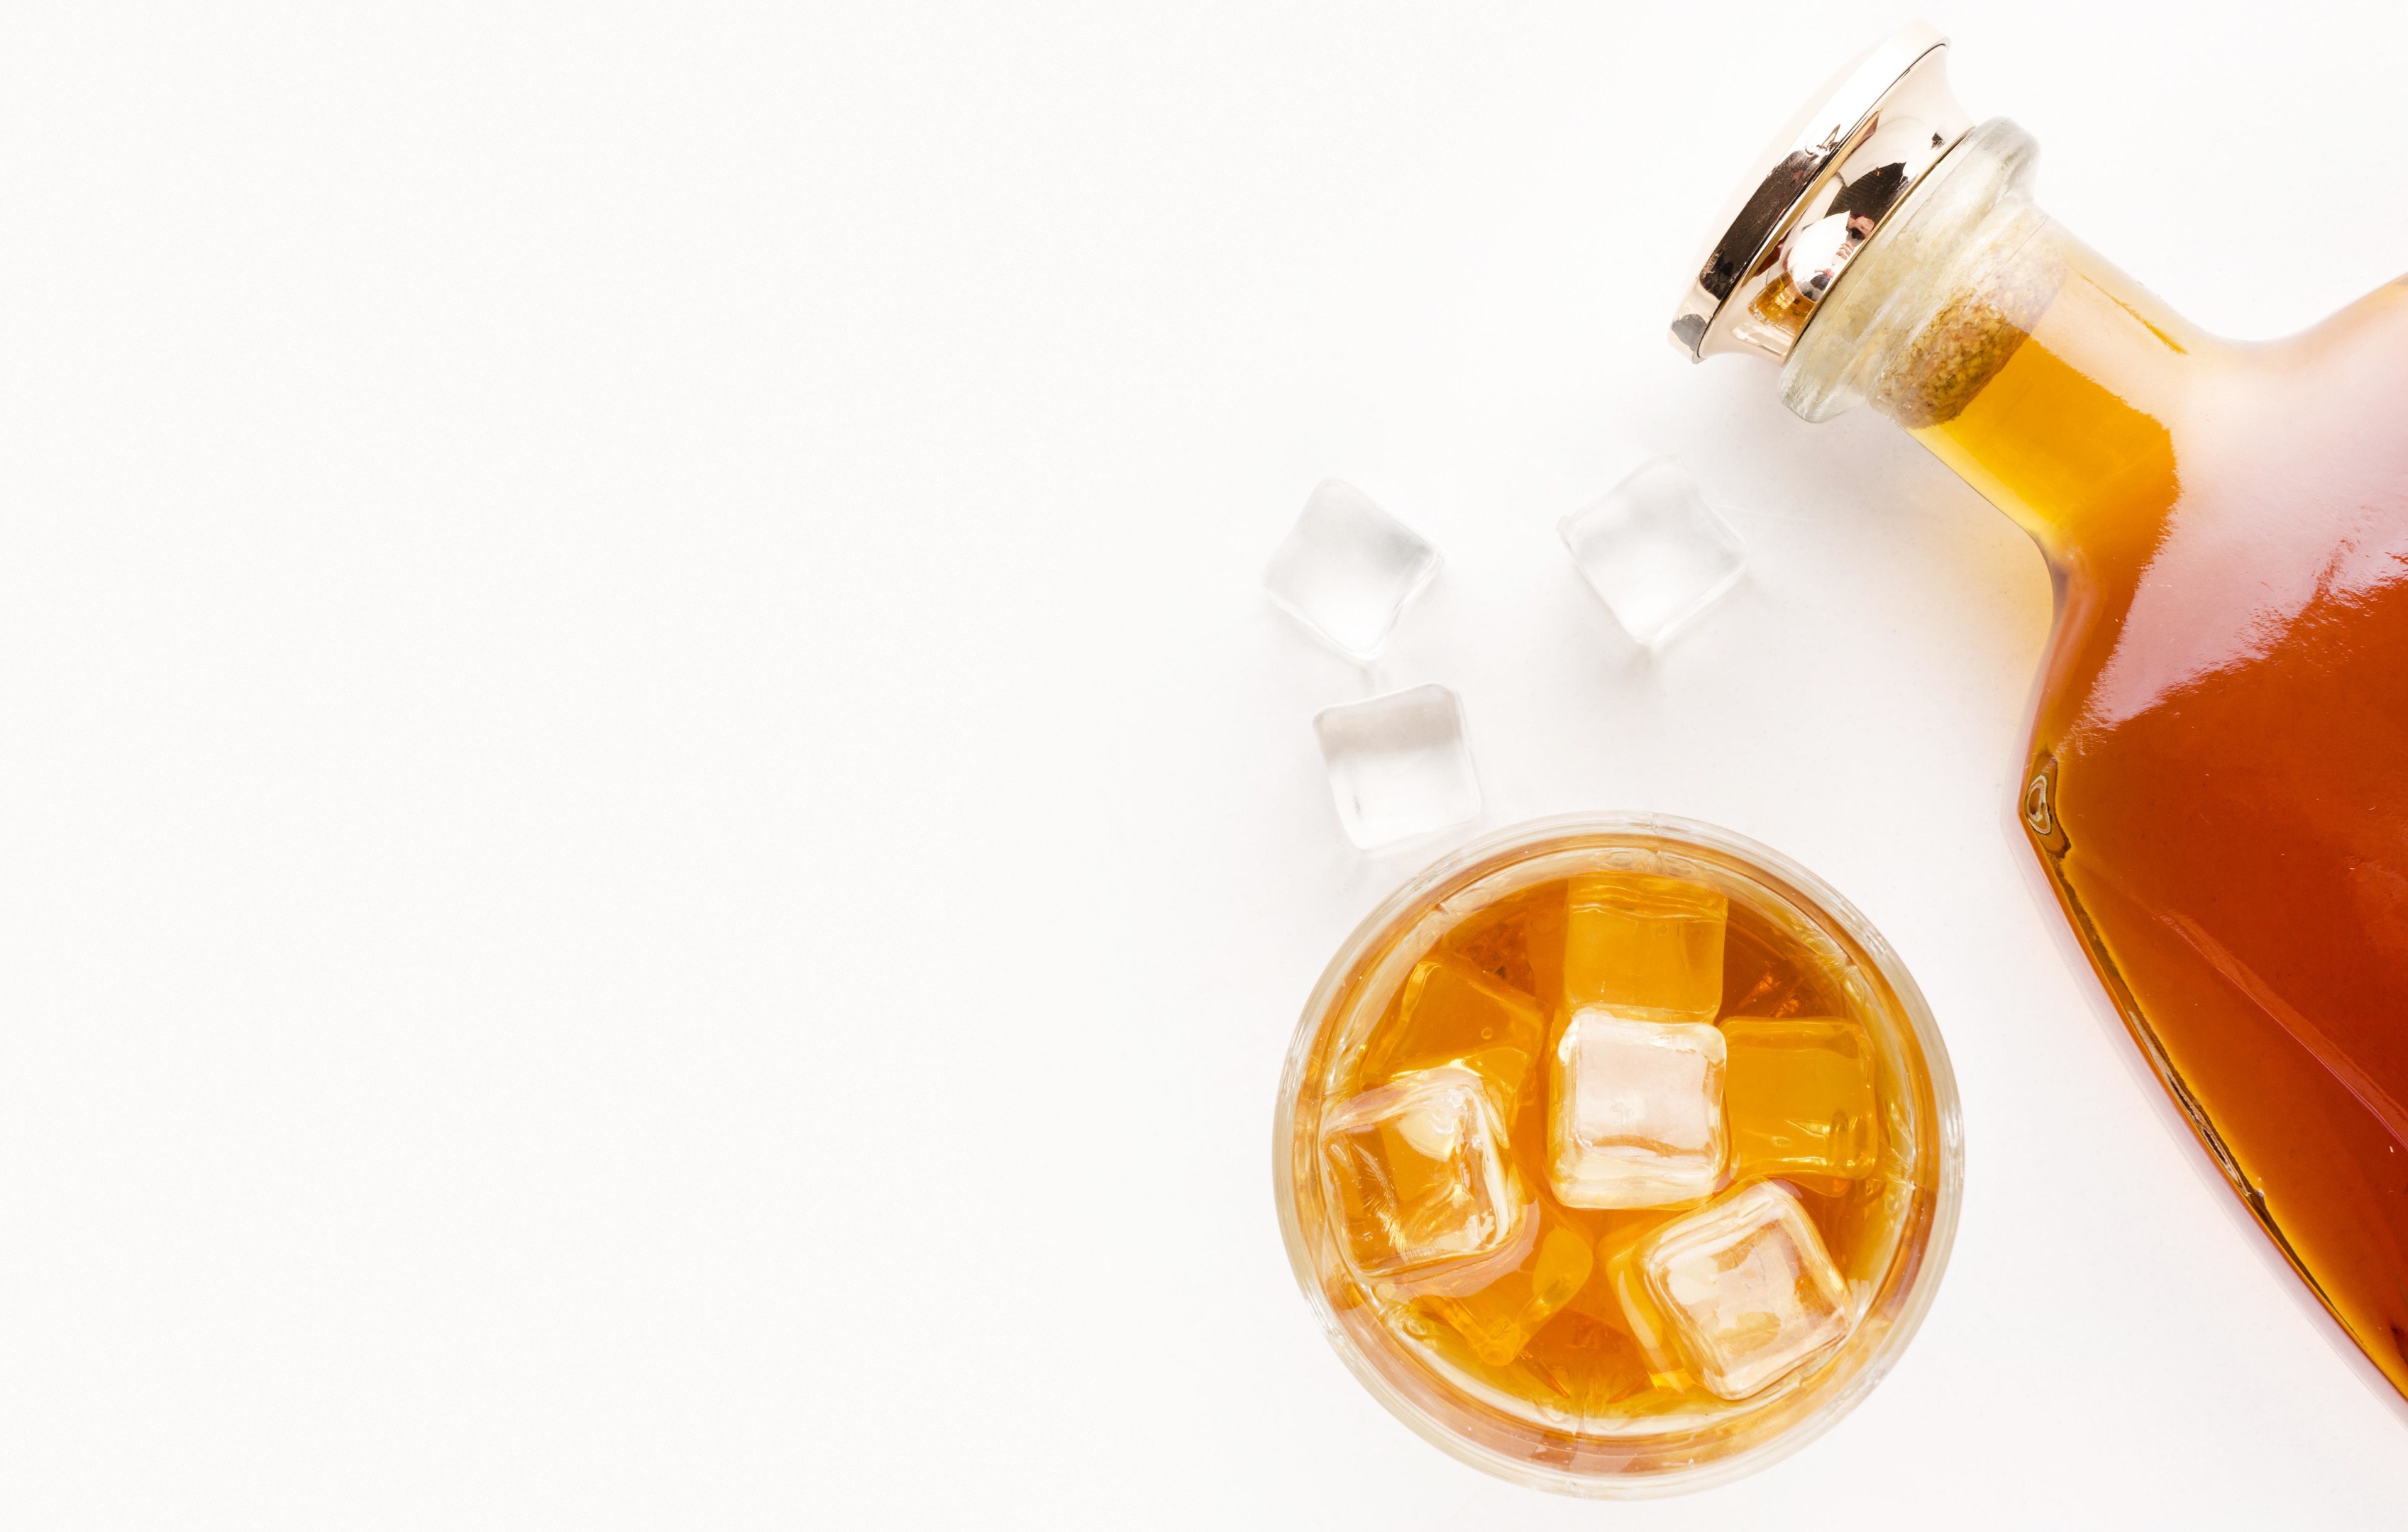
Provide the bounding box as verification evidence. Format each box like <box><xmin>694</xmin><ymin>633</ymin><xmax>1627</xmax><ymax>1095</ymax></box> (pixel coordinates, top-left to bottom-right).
<box><xmin>1261</xmin><ymin>479</ymin><xmax>1437</xmax><ymax>660</ymax></box>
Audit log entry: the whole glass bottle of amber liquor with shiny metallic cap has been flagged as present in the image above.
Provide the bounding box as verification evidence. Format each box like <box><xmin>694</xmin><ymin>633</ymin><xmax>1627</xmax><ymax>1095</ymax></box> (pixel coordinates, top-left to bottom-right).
<box><xmin>1674</xmin><ymin>26</ymin><xmax>2408</xmax><ymax>1394</ymax></box>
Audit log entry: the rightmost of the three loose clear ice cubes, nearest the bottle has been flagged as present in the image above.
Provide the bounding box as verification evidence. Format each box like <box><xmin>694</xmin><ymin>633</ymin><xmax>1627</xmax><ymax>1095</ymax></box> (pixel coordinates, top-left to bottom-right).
<box><xmin>1556</xmin><ymin>457</ymin><xmax>1748</xmax><ymax>648</ymax></box>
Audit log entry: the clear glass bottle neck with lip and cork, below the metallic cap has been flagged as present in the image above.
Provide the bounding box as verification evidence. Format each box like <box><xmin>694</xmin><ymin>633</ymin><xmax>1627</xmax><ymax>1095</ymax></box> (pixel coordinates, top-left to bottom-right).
<box><xmin>1782</xmin><ymin>121</ymin><xmax>2215</xmax><ymax>569</ymax></box>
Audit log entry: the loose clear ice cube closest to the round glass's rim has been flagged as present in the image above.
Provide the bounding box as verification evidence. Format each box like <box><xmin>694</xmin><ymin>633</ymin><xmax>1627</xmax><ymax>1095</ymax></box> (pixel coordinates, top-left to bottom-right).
<box><xmin>1313</xmin><ymin>687</ymin><xmax>1481</xmax><ymax>850</ymax></box>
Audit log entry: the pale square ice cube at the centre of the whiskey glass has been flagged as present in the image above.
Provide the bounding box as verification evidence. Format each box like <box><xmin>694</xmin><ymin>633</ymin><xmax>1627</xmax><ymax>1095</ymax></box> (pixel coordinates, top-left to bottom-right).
<box><xmin>1546</xmin><ymin>1007</ymin><xmax>1726</xmax><ymax>1207</ymax></box>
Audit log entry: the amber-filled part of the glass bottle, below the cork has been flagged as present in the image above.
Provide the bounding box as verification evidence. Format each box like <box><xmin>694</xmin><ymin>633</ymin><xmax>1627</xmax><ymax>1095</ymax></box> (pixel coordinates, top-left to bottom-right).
<box><xmin>1917</xmin><ymin>233</ymin><xmax>2408</xmax><ymax>1392</ymax></box>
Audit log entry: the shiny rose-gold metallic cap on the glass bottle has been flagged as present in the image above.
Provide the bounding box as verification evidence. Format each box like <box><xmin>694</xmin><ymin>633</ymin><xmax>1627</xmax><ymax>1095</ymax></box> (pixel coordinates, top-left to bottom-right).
<box><xmin>1671</xmin><ymin>22</ymin><xmax>1972</xmax><ymax>361</ymax></box>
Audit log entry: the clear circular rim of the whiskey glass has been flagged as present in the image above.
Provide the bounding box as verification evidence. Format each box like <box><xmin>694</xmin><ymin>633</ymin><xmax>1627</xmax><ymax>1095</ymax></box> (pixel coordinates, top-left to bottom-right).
<box><xmin>1271</xmin><ymin>814</ymin><xmax>1965</xmax><ymax>1498</ymax></box>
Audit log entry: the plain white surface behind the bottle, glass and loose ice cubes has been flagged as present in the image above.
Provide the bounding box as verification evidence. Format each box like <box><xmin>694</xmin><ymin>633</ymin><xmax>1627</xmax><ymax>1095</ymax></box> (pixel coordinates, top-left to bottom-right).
<box><xmin>0</xmin><ymin>0</ymin><xmax>2408</xmax><ymax>1532</ymax></box>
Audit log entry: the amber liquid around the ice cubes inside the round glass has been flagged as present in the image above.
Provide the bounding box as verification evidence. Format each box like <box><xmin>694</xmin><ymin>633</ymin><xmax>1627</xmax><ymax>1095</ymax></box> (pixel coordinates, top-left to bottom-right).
<box><xmin>1332</xmin><ymin>879</ymin><xmax>1905</xmax><ymax>1431</ymax></box>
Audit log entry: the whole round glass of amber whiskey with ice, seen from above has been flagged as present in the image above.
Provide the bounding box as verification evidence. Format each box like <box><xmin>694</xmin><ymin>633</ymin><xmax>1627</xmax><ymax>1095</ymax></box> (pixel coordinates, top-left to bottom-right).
<box><xmin>1278</xmin><ymin>819</ymin><xmax>1960</xmax><ymax>1494</ymax></box>
